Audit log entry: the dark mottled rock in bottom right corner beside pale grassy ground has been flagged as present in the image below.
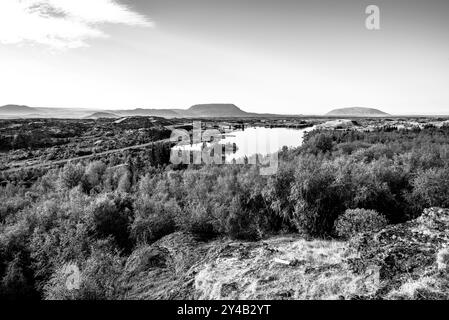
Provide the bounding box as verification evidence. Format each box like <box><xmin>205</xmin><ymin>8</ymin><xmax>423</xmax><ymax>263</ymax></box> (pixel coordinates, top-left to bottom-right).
<box><xmin>348</xmin><ymin>208</ymin><xmax>449</xmax><ymax>299</ymax></box>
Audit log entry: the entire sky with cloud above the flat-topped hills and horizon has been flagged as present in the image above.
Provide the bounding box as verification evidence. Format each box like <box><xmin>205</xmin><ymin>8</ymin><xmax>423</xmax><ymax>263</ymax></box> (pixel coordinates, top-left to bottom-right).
<box><xmin>0</xmin><ymin>0</ymin><xmax>449</xmax><ymax>114</ymax></box>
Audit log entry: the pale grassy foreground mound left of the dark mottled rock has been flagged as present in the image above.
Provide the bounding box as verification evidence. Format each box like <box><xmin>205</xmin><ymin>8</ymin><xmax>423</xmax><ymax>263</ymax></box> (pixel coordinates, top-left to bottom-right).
<box><xmin>121</xmin><ymin>233</ymin><xmax>377</xmax><ymax>299</ymax></box>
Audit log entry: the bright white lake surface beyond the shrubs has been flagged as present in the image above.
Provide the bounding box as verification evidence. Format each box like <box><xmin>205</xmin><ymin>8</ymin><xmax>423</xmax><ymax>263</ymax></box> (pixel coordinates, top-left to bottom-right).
<box><xmin>174</xmin><ymin>127</ymin><xmax>314</xmax><ymax>163</ymax></box>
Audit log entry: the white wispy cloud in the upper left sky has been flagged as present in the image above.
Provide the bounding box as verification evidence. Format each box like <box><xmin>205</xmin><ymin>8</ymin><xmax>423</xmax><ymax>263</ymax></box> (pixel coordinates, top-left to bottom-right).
<box><xmin>0</xmin><ymin>0</ymin><xmax>153</xmax><ymax>49</ymax></box>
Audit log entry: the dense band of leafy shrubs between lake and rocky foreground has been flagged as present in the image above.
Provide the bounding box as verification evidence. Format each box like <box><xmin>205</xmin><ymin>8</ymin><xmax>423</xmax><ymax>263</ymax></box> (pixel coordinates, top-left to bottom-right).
<box><xmin>0</xmin><ymin>124</ymin><xmax>449</xmax><ymax>299</ymax></box>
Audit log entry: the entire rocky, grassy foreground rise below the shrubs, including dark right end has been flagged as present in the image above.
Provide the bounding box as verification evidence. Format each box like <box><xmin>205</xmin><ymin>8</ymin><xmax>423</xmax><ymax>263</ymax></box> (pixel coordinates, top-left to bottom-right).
<box><xmin>121</xmin><ymin>208</ymin><xmax>449</xmax><ymax>299</ymax></box>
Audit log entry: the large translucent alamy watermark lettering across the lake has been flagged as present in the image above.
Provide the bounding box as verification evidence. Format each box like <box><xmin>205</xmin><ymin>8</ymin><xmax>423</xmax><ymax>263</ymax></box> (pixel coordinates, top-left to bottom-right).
<box><xmin>170</xmin><ymin>121</ymin><xmax>282</xmax><ymax>175</ymax></box>
